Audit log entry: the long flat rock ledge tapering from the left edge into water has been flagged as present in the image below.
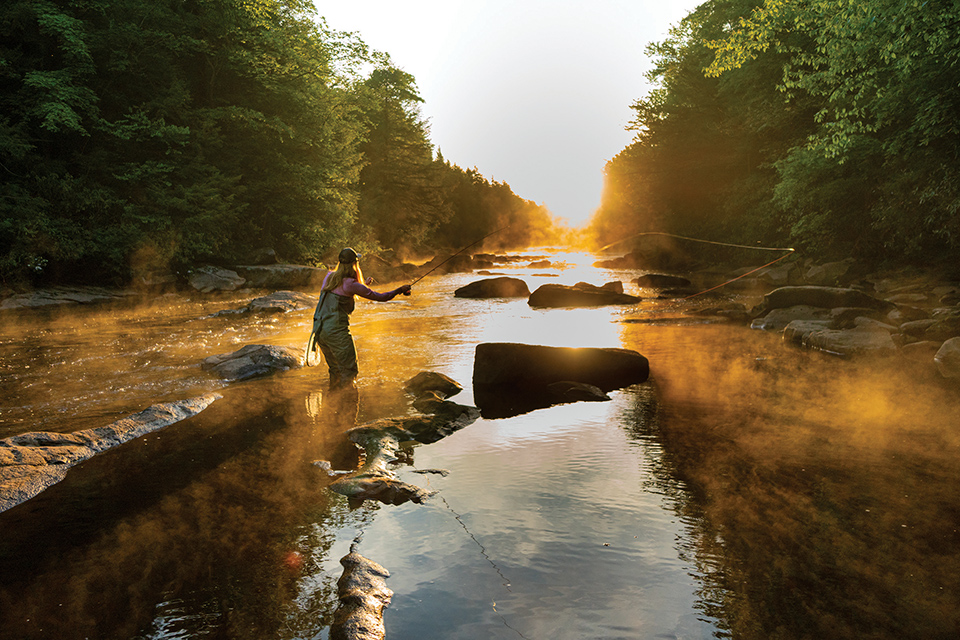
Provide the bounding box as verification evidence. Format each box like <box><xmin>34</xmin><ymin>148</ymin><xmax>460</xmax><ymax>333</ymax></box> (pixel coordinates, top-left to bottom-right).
<box><xmin>0</xmin><ymin>393</ymin><xmax>222</xmax><ymax>512</ymax></box>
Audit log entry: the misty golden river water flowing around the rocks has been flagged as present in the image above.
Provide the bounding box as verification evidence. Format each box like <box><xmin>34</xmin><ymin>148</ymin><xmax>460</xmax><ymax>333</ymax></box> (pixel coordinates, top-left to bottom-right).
<box><xmin>0</xmin><ymin>253</ymin><xmax>960</xmax><ymax>640</ymax></box>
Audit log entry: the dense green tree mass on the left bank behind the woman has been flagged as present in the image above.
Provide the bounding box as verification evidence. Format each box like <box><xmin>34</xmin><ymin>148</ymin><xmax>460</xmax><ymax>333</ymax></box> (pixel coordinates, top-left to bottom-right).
<box><xmin>0</xmin><ymin>0</ymin><xmax>568</xmax><ymax>286</ymax></box>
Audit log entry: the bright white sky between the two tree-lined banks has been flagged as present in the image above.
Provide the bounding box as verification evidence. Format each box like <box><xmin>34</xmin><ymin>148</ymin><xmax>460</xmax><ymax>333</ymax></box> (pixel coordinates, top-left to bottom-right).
<box><xmin>316</xmin><ymin>0</ymin><xmax>703</xmax><ymax>226</ymax></box>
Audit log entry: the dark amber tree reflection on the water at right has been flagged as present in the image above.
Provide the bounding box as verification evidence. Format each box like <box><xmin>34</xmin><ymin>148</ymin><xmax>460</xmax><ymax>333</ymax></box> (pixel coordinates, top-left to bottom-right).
<box><xmin>624</xmin><ymin>325</ymin><xmax>960</xmax><ymax>639</ymax></box>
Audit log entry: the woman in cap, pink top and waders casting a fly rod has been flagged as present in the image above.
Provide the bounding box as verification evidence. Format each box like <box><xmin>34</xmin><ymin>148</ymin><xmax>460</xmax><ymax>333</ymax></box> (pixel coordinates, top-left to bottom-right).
<box><xmin>307</xmin><ymin>247</ymin><xmax>411</xmax><ymax>389</ymax></box>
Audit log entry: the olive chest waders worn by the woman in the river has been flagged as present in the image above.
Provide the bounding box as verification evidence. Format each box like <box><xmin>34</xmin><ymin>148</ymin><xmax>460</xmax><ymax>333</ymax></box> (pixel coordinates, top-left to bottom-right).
<box><xmin>307</xmin><ymin>291</ymin><xmax>360</xmax><ymax>386</ymax></box>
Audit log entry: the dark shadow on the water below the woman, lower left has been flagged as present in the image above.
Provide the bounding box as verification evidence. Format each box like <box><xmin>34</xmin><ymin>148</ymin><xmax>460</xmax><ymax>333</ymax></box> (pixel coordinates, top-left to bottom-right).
<box><xmin>0</xmin><ymin>378</ymin><xmax>369</xmax><ymax>639</ymax></box>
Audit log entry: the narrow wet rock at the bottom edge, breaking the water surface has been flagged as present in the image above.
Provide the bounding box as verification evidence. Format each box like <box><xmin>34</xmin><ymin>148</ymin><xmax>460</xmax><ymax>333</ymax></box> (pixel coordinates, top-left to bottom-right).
<box><xmin>330</xmin><ymin>547</ymin><xmax>393</xmax><ymax>640</ymax></box>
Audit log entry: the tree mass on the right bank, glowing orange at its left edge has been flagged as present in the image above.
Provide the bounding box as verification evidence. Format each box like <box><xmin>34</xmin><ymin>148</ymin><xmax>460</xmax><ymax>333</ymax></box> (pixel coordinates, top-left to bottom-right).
<box><xmin>593</xmin><ymin>0</ymin><xmax>960</xmax><ymax>261</ymax></box>
